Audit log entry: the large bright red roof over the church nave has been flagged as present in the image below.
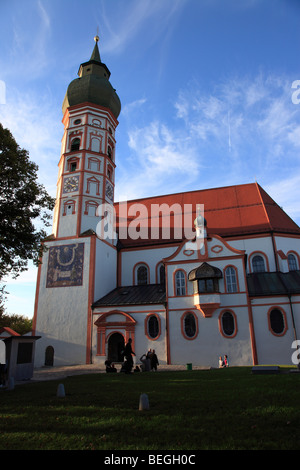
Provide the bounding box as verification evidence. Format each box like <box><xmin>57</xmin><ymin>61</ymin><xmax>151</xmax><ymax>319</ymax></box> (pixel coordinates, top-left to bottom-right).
<box><xmin>115</xmin><ymin>183</ymin><xmax>300</xmax><ymax>247</ymax></box>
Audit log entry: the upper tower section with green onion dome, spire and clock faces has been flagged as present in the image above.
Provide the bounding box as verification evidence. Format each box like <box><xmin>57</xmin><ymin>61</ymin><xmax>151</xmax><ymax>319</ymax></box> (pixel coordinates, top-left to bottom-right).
<box><xmin>53</xmin><ymin>36</ymin><xmax>121</xmax><ymax>238</ymax></box>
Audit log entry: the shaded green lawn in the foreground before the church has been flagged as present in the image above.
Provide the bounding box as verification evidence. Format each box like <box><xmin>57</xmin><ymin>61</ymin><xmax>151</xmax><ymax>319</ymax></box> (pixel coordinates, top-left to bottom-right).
<box><xmin>0</xmin><ymin>368</ymin><xmax>300</xmax><ymax>450</ymax></box>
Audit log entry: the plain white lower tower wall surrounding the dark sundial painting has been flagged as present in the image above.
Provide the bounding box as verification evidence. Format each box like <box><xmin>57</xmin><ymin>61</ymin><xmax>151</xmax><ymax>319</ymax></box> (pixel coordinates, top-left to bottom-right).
<box><xmin>35</xmin><ymin>238</ymin><xmax>90</xmax><ymax>367</ymax></box>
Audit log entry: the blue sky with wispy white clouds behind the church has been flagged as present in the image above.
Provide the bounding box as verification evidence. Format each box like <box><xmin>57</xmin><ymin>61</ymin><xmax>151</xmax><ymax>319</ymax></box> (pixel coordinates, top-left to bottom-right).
<box><xmin>0</xmin><ymin>0</ymin><xmax>300</xmax><ymax>317</ymax></box>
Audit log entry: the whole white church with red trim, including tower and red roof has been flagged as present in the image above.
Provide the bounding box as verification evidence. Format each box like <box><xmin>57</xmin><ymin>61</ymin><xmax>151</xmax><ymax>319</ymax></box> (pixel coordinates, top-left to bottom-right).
<box><xmin>32</xmin><ymin>38</ymin><xmax>300</xmax><ymax>367</ymax></box>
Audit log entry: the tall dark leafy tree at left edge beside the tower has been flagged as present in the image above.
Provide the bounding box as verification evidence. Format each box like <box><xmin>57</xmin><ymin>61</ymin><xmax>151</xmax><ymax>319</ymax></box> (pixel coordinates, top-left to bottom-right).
<box><xmin>0</xmin><ymin>124</ymin><xmax>55</xmax><ymax>281</ymax></box>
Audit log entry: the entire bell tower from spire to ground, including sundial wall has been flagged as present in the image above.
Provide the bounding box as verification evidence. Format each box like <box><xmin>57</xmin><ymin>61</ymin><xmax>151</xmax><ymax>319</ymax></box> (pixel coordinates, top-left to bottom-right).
<box><xmin>33</xmin><ymin>36</ymin><xmax>121</xmax><ymax>367</ymax></box>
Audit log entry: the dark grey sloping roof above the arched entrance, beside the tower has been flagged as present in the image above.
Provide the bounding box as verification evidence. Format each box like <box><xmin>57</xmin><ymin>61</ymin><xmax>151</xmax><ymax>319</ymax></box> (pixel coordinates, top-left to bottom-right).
<box><xmin>92</xmin><ymin>284</ymin><xmax>166</xmax><ymax>308</ymax></box>
